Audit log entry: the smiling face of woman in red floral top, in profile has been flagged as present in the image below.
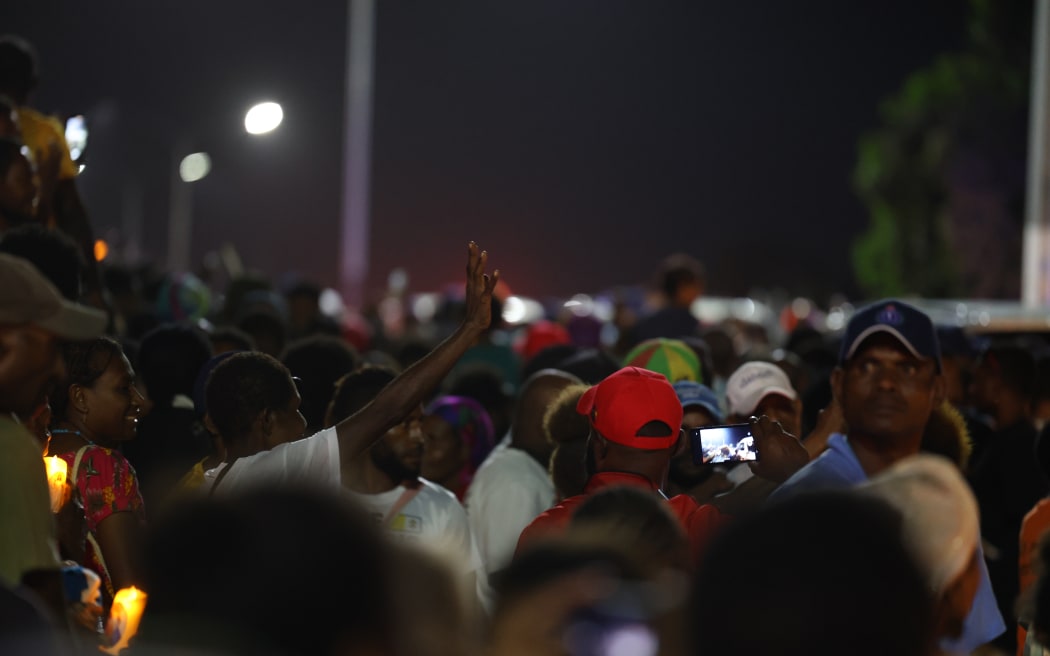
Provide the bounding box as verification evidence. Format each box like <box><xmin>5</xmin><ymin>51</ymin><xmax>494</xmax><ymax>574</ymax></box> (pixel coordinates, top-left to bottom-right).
<box><xmin>84</xmin><ymin>354</ymin><xmax>143</xmax><ymax>444</ymax></box>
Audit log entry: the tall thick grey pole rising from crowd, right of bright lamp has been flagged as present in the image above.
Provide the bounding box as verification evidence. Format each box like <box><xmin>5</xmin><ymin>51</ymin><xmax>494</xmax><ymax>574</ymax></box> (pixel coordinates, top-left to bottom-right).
<box><xmin>339</xmin><ymin>0</ymin><xmax>376</xmax><ymax>308</ymax></box>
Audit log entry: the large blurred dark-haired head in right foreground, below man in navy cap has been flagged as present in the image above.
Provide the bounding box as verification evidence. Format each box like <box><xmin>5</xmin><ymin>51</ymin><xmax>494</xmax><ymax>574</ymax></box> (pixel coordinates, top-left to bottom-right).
<box><xmin>690</xmin><ymin>491</ymin><xmax>935</xmax><ymax>656</ymax></box>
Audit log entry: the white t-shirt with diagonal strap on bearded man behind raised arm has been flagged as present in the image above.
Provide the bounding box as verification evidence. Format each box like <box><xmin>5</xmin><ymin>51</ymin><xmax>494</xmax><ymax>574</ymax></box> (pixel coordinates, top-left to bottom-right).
<box><xmin>343</xmin><ymin>478</ymin><xmax>481</xmax><ymax>572</ymax></box>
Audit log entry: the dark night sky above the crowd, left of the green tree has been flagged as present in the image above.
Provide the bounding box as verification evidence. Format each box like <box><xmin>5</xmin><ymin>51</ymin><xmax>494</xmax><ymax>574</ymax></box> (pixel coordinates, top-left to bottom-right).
<box><xmin>0</xmin><ymin>0</ymin><xmax>966</xmax><ymax>300</ymax></box>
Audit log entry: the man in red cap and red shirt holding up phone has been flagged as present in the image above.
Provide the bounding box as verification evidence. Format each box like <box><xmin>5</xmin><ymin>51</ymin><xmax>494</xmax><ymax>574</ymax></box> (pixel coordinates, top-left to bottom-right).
<box><xmin>518</xmin><ymin>366</ymin><xmax>809</xmax><ymax>554</ymax></box>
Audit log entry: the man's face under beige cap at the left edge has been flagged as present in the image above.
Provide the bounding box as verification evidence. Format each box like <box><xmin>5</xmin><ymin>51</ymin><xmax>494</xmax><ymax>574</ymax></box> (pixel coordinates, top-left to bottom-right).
<box><xmin>0</xmin><ymin>324</ymin><xmax>65</xmax><ymax>418</ymax></box>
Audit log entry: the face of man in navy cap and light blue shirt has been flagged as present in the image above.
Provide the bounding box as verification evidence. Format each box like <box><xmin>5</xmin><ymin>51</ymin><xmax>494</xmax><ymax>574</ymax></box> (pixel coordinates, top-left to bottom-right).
<box><xmin>832</xmin><ymin>333</ymin><xmax>944</xmax><ymax>445</ymax></box>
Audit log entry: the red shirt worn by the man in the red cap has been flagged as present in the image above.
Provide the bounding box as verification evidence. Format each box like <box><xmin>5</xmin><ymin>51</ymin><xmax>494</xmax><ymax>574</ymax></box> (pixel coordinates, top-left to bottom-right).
<box><xmin>515</xmin><ymin>471</ymin><xmax>726</xmax><ymax>556</ymax></box>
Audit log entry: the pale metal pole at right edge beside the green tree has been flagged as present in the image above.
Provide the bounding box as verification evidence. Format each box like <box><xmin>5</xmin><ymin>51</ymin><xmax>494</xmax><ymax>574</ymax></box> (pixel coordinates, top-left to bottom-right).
<box><xmin>1022</xmin><ymin>0</ymin><xmax>1050</xmax><ymax>308</ymax></box>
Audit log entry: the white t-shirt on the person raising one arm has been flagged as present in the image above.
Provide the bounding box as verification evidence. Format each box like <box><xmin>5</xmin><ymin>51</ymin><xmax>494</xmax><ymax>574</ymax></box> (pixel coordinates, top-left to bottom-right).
<box><xmin>201</xmin><ymin>428</ymin><xmax>341</xmax><ymax>494</ymax></box>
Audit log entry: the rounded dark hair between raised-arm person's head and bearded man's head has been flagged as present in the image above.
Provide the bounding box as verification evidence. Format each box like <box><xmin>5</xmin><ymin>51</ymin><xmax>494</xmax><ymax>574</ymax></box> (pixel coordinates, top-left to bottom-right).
<box><xmin>280</xmin><ymin>335</ymin><xmax>359</xmax><ymax>433</ymax></box>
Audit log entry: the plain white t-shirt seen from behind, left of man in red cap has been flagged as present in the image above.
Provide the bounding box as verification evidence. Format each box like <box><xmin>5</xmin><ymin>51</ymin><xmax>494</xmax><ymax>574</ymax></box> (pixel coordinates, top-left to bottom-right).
<box><xmin>465</xmin><ymin>439</ymin><xmax>554</xmax><ymax>574</ymax></box>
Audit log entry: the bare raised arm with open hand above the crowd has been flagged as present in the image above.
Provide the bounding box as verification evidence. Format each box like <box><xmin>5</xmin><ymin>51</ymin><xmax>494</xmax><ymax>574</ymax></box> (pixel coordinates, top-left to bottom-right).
<box><xmin>335</xmin><ymin>241</ymin><xmax>500</xmax><ymax>470</ymax></box>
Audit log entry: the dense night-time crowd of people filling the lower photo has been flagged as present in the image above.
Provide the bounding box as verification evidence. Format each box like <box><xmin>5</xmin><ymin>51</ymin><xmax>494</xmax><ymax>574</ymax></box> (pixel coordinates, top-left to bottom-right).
<box><xmin>8</xmin><ymin>30</ymin><xmax>1050</xmax><ymax>656</ymax></box>
